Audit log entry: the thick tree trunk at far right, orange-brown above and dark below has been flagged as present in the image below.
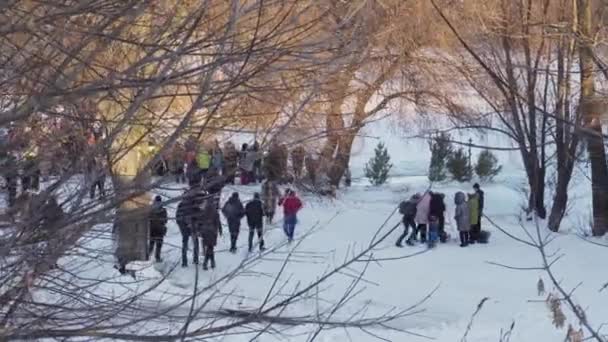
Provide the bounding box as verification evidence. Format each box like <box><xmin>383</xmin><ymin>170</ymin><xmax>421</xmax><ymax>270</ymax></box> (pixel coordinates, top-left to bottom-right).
<box><xmin>577</xmin><ymin>0</ymin><xmax>608</xmax><ymax>236</ymax></box>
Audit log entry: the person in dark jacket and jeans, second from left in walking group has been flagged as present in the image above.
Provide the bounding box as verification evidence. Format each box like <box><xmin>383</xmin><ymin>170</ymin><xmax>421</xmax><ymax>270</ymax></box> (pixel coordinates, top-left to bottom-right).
<box><xmin>175</xmin><ymin>190</ymin><xmax>201</xmax><ymax>267</ymax></box>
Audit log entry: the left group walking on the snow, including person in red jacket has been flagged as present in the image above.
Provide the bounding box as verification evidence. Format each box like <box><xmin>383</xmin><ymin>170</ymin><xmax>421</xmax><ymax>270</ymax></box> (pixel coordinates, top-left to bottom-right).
<box><xmin>148</xmin><ymin>176</ymin><xmax>303</xmax><ymax>270</ymax></box>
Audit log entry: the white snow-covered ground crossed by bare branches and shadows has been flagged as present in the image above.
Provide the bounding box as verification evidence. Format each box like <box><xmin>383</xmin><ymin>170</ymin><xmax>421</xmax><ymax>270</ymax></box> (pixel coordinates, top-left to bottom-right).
<box><xmin>26</xmin><ymin>119</ymin><xmax>608</xmax><ymax>342</ymax></box>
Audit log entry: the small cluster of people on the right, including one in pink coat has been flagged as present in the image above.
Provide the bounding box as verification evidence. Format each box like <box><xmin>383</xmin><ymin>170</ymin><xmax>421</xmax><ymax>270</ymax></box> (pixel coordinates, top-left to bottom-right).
<box><xmin>396</xmin><ymin>183</ymin><xmax>487</xmax><ymax>247</ymax></box>
